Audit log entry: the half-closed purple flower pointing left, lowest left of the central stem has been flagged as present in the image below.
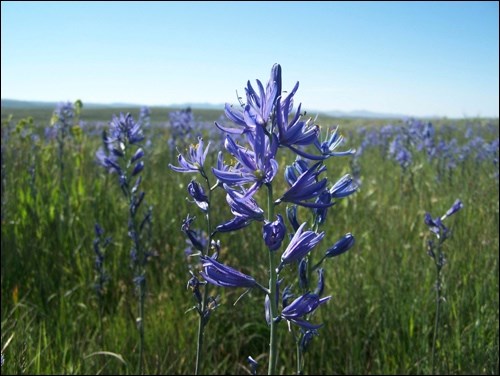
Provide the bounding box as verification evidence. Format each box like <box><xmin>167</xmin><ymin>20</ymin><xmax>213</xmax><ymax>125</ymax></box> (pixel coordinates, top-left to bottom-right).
<box><xmin>200</xmin><ymin>256</ymin><xmax>257</xmax><ymax>288</ymax></box>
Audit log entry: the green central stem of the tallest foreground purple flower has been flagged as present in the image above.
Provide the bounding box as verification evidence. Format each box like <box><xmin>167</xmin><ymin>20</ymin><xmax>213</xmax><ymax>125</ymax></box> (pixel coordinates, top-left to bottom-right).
<box><xmin>266</xmin><ymin>183</ymin><xmax>278</xmax><ymax>375</ymax></box>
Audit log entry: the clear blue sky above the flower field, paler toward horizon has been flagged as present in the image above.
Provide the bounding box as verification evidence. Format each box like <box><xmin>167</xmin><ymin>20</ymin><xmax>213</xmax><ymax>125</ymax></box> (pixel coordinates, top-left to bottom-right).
<box><xmin>1</xmin><ymin>1</ymin><xmax>499</xmax><ymax>118</ymax></box>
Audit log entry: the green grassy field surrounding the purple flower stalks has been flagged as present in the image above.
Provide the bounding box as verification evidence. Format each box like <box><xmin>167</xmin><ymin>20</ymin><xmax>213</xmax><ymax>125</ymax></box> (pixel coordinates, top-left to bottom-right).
<box><xmin>1</xmin><ymin>104</ymin><xmax>499</xmax><ymax>374</ymax></box>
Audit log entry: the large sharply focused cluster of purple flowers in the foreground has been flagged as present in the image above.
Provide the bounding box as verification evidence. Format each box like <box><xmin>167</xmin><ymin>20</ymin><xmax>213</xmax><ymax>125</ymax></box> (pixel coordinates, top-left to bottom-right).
<box><xmin>170</xmin><ymin>64</ymin><xmax>357</xmax><ymax>370</ymax></box>
